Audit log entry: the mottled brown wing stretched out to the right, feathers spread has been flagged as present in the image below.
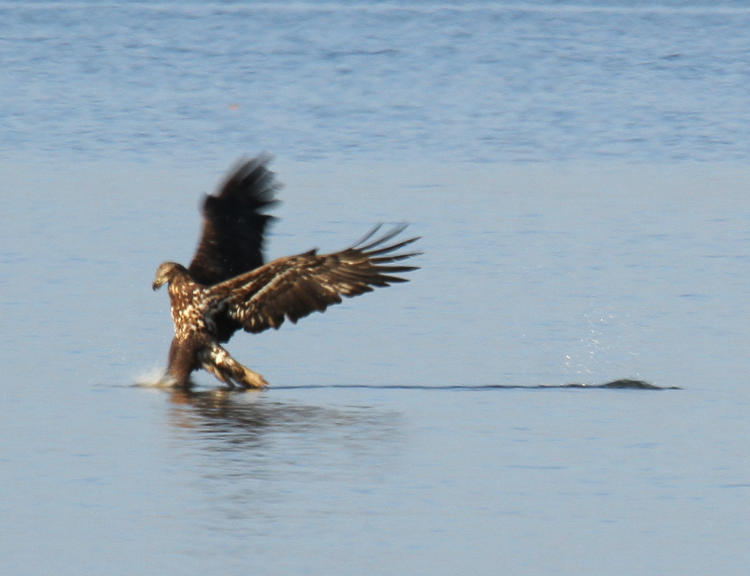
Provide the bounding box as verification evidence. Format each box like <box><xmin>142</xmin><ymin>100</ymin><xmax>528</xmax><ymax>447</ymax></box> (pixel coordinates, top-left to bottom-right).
<box><xmin>211</xmin><ymin>225</ymin><xmax>418</xmax><ymax>332</ymax></box>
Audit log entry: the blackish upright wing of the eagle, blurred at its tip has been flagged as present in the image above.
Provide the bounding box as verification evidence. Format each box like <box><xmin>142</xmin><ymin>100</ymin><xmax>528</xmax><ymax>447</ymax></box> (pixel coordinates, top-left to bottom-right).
<box><xmin>188</xmin><ymin>156</ymin><xmax>278</xmax><ymax>285</ymax></box>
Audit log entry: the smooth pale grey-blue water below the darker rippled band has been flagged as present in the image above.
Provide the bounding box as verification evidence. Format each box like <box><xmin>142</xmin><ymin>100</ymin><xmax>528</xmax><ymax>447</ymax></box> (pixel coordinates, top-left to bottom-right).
<box><xmin>2</xmin><ymin>162</ymin><xmax>750</xmax><ymax>574</ymax></box>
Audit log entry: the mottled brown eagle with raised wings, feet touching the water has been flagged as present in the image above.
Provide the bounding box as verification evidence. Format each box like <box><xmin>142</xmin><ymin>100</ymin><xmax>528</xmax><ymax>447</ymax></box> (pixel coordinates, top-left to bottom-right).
<box><xmin>153</xmin><ymin>156</ymin><xmax>418</xmax><ymax>388</ymax></box>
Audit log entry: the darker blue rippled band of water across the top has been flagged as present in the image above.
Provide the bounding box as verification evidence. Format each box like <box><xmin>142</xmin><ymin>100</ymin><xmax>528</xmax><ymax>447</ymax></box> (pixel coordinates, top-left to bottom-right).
<box><xmin>0</xmin><ymin>2</ymin><xmax>750</xmax><ymax>164</ymax></box>
